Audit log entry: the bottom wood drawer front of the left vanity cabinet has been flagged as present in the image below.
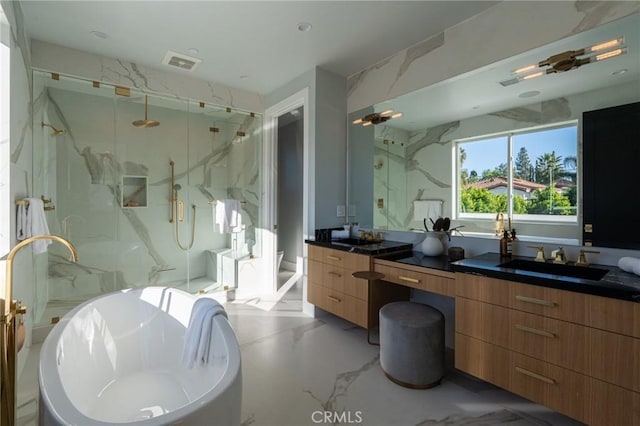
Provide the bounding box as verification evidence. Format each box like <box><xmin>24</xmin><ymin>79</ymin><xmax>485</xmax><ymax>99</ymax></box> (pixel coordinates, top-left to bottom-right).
<box><xmin>307</xmin><ymin>283</ymin><xmax>367</xmax><ymax>328</ymax></box>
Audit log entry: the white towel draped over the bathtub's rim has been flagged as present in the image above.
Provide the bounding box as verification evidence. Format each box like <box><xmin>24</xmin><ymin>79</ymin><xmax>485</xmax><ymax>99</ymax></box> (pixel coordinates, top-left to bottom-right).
<box><xmin>182</xmin><ymin>297</ymin><xmax>227</xmax><ymax>368</ymax></box>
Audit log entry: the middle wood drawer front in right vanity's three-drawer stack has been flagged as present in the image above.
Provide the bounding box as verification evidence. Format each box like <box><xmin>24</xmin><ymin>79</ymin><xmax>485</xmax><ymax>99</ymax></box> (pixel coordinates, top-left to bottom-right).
<box><xmin>456</xmin><ymin>297</ymin><xmax>590</xmax><ymax>374</ymax></box>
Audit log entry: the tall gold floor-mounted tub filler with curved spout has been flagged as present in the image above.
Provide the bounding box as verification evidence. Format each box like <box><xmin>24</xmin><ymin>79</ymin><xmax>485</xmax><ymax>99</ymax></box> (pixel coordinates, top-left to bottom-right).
<box><xmin>0</xmin><ymin>235</ymin><xmax>78</xmax><ymax>426</ymax></box>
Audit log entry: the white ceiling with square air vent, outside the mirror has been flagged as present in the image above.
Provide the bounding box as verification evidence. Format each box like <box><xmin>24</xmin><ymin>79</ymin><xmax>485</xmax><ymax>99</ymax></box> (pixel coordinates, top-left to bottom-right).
<box><xmin>21</xmin><ymin>0</ymin><xmax>498</xmax><ymax>94</ymax></box>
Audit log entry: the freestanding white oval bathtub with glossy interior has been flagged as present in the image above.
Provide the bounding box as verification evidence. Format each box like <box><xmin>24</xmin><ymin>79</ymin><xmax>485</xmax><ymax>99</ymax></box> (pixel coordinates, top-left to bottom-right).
<box><xmin>38</xmin><ymin>287</ymin><xmax>242</xmax><ymax>426</ymax></box>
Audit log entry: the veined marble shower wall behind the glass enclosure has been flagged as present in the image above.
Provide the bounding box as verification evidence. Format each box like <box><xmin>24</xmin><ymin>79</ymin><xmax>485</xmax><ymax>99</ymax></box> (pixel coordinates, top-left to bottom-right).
<box><xmin>34</xmin><ymin>73</ymin><xmax>262</xmax><ymax>314</ymax></box>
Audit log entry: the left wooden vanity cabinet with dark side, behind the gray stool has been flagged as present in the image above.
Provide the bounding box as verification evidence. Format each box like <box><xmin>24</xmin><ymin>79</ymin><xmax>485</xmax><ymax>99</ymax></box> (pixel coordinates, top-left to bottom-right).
<box><xmin>307</xmin><ymin>245</ymin><xmax>409</xmax><ymax>329</ymax></box>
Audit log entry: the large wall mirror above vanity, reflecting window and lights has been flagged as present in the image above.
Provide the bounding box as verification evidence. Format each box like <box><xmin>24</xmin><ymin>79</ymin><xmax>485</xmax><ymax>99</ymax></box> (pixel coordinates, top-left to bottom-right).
<box><xmin>348</xmin><ymin>14</ymin><xmax>640</xmax><ymax>244</ymax></box>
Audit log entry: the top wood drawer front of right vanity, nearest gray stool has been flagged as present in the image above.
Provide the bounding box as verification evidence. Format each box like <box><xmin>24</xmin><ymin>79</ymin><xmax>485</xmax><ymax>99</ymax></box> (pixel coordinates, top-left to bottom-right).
<box><xmin>456</xmin><ymin>274</ymin><xmax>589</xmax><ymax>324</ymax></box>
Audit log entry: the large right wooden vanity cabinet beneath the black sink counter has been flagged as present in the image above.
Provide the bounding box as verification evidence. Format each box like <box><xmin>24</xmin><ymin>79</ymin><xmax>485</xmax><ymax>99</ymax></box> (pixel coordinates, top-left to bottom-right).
<box><xmin>455</xmin><ymin>274</ymin><xmax>640</xmax><ymax>425</ymax></box>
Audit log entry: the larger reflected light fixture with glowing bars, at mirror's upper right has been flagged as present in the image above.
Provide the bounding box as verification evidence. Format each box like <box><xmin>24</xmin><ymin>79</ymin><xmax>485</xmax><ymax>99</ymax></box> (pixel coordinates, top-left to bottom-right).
<box><xmin>512</xmin><ymin>37</ymin><xmax>627</xmax><ymax>81</ymax></box>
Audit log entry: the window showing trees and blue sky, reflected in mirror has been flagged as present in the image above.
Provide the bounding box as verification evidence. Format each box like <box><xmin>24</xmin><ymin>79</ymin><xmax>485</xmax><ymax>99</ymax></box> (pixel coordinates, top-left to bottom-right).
<box><xmin>455</xmin><ymin>122</ymin><xmax>578</xmax><ymax>222</ymax></box>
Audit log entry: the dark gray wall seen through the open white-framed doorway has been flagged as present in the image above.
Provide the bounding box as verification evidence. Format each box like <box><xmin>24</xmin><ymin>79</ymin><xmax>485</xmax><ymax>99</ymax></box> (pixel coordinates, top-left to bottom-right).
<box><xmin>278</xmin><ymin>114</ymin><xmax>304</xmax><ymax>263</ymax></box>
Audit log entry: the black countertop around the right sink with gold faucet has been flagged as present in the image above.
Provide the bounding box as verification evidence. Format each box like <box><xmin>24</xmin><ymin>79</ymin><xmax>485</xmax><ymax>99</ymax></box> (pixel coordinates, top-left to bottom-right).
<box><xmin>450</xmin><ymin>253</ymin><xmax>640</xmax><ymax>303</ymax></box>
